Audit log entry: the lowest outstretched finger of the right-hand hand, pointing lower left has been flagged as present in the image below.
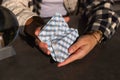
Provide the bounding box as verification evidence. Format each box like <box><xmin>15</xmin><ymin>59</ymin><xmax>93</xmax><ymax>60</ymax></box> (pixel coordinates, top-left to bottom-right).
<box><xmin>58</xmin><ymin>49</ymin><xmax>84</xmax><ymax>67</ymax></box>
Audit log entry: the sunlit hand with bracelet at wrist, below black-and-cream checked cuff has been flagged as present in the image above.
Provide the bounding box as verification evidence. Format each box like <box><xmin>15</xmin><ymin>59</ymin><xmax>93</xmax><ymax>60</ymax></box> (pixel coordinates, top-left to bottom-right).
<box><xmin>58</xmin><ymin>33</ymin><xmax>101</xmax><ymax>67</ymax></box>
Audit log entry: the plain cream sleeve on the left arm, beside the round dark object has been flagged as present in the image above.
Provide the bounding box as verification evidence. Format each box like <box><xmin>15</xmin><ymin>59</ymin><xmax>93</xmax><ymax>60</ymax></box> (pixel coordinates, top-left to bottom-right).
<box><xmin>2</xmin><ymin>0</ymin><xmax>37</xmax><ymax>33</ymax></box>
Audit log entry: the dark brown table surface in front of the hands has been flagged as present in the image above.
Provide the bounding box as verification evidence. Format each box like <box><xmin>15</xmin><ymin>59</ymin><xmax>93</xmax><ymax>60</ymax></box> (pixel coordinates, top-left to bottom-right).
<box><xmin>0</xmin><ymin>25</ymin><xmax>120</xmax><ymax>80</ymax></box>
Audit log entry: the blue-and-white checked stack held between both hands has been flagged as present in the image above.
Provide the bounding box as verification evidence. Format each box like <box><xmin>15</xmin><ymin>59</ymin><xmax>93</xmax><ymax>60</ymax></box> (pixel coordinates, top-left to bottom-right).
<box><xmin>38</xmin><ymin>13</ymin><xmax>79</xmax><ymax>62</ymax></box>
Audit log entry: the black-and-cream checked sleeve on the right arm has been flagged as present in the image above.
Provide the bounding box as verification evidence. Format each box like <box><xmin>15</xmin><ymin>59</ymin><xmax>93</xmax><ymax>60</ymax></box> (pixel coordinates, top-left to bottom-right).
<box><xmin>85</xmin><ymin>0</ymin><xmax>120</xmax><ymax>40</ymax></box>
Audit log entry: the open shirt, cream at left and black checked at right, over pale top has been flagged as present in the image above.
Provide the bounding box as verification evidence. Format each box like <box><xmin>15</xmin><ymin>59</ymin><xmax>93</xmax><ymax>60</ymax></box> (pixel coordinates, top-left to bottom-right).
<box><xmin>2</xmin><ymin>0</ymin><xmax>120</xmax><ymax>39</ymax></box>
